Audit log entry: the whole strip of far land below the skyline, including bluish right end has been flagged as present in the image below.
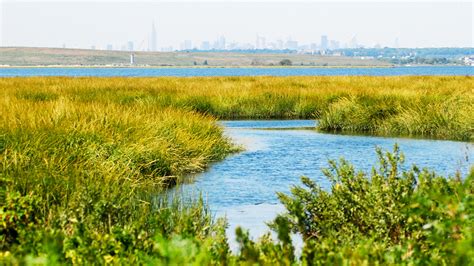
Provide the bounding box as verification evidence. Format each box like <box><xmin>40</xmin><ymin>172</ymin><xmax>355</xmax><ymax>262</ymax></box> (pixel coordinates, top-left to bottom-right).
<box><xmin>0</xmin><ymin>47</ymin><xmax>470</xmax><ymax>68</ymax></box>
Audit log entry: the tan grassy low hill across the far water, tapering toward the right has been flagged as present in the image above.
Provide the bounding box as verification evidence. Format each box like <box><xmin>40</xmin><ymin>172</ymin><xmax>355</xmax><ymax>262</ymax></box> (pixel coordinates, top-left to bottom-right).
<box><xmin>0</xmin><ymin>47</ymin><xmax>393</xmax><ymax>68</ymax></box>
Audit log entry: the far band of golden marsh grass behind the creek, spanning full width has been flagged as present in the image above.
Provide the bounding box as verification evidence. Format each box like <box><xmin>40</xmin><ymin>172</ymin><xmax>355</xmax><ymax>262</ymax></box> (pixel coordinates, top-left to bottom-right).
<box><xmin>0</xmin><ymin>76</ymin><xmax>474</xmax><ymax>141</ymax></box>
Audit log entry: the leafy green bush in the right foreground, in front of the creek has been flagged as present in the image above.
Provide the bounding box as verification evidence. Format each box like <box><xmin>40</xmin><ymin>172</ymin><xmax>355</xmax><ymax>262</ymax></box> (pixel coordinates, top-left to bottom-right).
<box><xmin>278</xmin><ymin>146</ymin><xmax>474</xmax><ymax>264</ymax></box>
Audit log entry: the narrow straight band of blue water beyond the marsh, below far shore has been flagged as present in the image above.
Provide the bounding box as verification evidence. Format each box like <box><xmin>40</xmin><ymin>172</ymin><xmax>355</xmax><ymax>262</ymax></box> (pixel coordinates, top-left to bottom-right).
<box><xmin>0</xmin><ymin>66</ymin><xmax>474</xmax><ymax>77</ymax></box>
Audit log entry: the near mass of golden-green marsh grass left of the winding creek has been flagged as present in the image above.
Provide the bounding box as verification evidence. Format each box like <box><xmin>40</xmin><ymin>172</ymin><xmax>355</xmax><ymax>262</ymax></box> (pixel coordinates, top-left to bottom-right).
<box><xmin>0</xmin><ymin>81</ymin><xmax>235</xmax><ymax>264</ymax></box>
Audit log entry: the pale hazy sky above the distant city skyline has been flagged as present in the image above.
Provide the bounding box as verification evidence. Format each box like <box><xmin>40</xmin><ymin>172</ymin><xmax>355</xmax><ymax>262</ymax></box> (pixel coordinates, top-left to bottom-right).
<box><xmin>0</xmin><ymin>0</ymin><xmax>474</xmax><ymax>50</ymax></box>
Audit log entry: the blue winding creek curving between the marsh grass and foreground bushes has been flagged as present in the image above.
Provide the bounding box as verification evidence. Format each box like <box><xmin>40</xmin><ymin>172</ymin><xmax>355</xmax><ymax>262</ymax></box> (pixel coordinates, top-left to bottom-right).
<box><xmin>172</xmin><ymin>120</ymin><xmax>474</xmax><ymax>243</ymax></box>
